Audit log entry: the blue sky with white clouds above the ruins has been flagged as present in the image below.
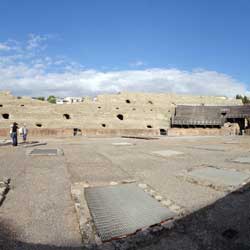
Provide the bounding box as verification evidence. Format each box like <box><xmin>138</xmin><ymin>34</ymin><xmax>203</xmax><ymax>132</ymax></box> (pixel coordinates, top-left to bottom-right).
<box><xmin>0</xmin><ymin>0</ymin><xmax>250</xmax><ymax>97</ymax></box>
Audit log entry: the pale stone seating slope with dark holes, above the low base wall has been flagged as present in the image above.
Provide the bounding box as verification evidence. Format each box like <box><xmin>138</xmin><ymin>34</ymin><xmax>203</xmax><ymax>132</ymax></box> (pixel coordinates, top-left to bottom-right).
<box><xmin>0</xmin><ymin>92</ymin><xmax>242</xmax><ymax>134</ymax></box>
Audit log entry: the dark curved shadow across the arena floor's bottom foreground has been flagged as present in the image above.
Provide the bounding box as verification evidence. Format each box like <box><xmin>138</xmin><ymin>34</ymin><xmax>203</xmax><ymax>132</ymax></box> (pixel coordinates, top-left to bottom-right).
<box><xmin>0</xmin><ymin>185</ymin><xmax>250</xmax><ymax>250</ymax></box>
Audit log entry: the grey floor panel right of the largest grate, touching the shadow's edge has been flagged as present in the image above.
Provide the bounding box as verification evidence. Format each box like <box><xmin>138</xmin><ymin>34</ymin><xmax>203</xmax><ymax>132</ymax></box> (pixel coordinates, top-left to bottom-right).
<box><xmin>186</xmin><ymin>167</ymin><xmax>250</xmax><ymax>190</ymax></box>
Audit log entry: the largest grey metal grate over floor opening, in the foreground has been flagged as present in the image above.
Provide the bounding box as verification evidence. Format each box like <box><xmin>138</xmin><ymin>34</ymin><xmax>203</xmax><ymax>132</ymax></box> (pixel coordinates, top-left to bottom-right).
<box><xmin>84</xmin><ymin>184</ymin><xmax>176</xmax><ymax>241</ymax></box>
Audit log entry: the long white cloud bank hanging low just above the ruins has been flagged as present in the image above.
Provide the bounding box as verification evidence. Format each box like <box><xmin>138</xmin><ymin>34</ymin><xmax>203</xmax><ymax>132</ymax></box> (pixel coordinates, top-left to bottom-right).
<box><xmin>0</xmin><ymin>35</ymin><xmax>247</xmax><ymax>96</ymax></box>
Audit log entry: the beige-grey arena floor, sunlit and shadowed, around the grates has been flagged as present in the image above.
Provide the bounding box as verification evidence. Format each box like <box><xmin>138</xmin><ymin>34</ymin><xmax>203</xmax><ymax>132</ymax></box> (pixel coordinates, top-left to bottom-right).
<box><xmin>0</xmin><ymin>136</ymin><xmax>250</xmax><ymax>250</ymax></box>
